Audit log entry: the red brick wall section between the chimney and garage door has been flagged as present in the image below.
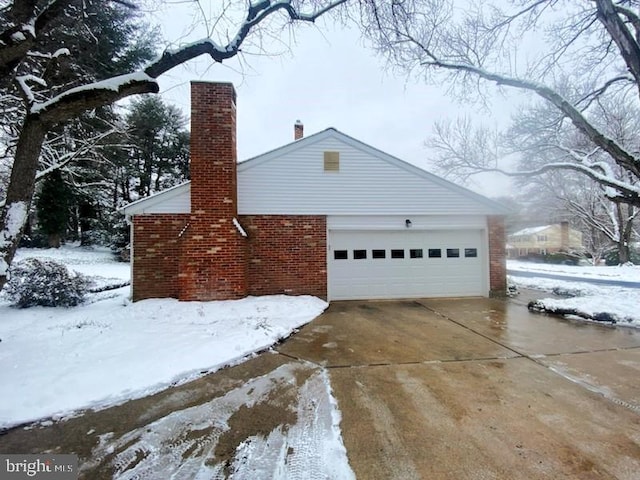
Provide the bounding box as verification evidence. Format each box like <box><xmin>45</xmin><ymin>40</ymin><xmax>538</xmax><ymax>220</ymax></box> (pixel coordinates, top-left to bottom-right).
<box><xmin>240</xmin><ymin>215</ymin><xmax>327</xmax><ymax>298</ymax></box>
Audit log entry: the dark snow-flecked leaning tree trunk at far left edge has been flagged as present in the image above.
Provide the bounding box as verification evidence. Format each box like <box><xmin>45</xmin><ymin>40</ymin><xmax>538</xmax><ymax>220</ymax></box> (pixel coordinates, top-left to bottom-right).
<box><xmin>0</xmin><ymin>116</ymin><xmax>45</xmax><ymax>288</ymax></box>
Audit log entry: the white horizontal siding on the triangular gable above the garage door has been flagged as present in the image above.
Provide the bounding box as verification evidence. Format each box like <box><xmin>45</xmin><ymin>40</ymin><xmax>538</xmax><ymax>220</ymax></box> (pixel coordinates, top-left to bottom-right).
<box><xmin>238</xmin><ymin>130</ymin><xmax>496</xmax><ymax>215</ymax></box>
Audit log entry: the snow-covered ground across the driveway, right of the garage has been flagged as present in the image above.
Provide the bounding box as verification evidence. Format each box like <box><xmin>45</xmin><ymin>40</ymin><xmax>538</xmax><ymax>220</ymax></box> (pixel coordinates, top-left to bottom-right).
<box><xmin>507</xmin><ymin>261</ymin><xmax>640</xmax><ymax>328</ymax></box>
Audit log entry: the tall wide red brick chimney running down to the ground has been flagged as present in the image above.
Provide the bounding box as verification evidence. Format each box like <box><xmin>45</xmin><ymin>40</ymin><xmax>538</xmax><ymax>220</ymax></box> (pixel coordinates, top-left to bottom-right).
<box><xmin>178</xmin><ymin>82</ymin><xmax>247</xmax><ymax>301</ymax></box>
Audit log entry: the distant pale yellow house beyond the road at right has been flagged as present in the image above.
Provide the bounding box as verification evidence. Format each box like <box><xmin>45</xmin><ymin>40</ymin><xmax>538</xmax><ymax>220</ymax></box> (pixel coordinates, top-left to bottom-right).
<box><xmin>507</xmin><ymin>222</ymin><xmax>584</xmax><ymax>258</ymax></box>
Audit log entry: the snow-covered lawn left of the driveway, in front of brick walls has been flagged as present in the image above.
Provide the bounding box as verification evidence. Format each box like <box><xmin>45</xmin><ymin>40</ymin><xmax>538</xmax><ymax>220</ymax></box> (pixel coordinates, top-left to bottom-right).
<box><xmin>0</xmin><ymin>247</ymin><xmax>327</xmax><ymax>428</ymax></box>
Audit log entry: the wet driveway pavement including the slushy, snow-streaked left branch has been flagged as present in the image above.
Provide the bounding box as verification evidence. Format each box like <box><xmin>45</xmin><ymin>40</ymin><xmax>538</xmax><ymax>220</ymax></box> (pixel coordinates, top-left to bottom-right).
<box><xmin>0</xmin><ymin>295</ymin><xmax>640</xmax><ymax>480</ymax></box>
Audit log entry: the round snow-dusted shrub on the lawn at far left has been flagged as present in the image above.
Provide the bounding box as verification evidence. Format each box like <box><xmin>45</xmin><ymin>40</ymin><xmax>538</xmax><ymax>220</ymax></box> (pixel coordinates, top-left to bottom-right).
<box><xmin>3</xmin><ymin>258</ymin><xmax>89</xmax><ymax>308</ymax></box>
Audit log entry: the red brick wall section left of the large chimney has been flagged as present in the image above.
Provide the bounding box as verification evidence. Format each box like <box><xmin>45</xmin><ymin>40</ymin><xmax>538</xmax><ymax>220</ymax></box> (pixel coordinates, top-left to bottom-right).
<box><xmin>132</xmin><ymin>214</ymin><xmax>189</xmax><ymax>301</ymax></box>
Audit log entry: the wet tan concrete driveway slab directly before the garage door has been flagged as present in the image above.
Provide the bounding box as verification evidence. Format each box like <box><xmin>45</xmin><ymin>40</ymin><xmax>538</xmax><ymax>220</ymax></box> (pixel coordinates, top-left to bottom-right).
<box><xmin>279</xmin><ymin>299</ymin><xmax>640</xmax><ymax>480</ymax></box>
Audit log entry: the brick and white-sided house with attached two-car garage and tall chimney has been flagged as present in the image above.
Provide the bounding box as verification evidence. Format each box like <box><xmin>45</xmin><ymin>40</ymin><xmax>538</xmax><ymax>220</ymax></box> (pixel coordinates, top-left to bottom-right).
<box><xmin>123</xmin><ymin>82</ymin><xmax>508</xmax><ymax>300</ymax></box>
